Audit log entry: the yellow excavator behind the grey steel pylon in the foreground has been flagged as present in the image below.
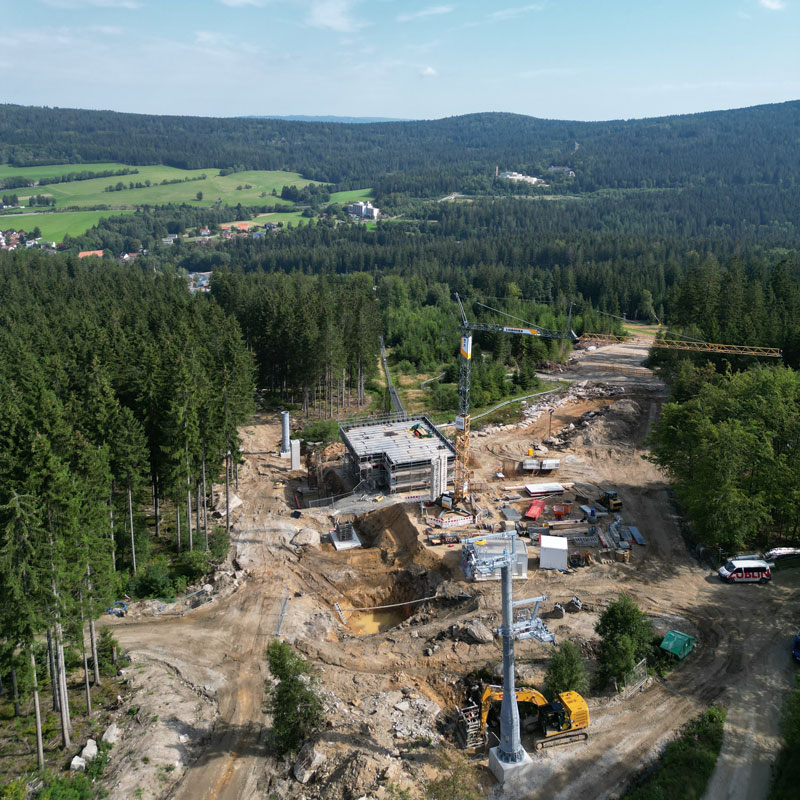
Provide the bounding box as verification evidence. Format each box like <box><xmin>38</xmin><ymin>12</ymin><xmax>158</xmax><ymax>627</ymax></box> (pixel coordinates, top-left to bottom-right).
<box><xmin>457</xmin><ymin>685</ymin><xmax>589</xmax><ymax>750</ymax></box>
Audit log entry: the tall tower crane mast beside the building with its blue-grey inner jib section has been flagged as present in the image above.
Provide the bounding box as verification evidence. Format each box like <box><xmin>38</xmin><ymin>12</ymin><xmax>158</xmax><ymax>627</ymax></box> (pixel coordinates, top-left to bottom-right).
<box><xmin>453</xmin><ymin>293</ymin><xmax>577</xmax><ymax>504</ymax></box>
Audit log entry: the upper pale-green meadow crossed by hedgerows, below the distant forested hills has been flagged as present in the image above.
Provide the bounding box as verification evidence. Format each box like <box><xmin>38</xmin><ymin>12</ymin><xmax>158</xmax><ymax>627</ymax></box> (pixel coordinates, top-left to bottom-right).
<box><xmin>0</xmin><ymin>164</ymin><xmax>312</xmax><ymax>208</ymax></box>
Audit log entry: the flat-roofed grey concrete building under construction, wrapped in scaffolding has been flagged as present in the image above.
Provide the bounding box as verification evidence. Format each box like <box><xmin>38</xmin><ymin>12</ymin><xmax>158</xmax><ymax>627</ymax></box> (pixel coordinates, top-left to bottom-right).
<box><xmin>339</xmin><ymin>417</ymin><xmax>456</xmax><ymax>495</ymax></box>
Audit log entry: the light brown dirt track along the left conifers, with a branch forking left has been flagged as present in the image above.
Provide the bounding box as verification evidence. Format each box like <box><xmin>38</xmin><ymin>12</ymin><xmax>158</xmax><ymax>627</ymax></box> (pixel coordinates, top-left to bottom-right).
<box><xmin>114</xmin><ymin>444</ymin><xmax>294</xmax><ymax>800</ymax></box>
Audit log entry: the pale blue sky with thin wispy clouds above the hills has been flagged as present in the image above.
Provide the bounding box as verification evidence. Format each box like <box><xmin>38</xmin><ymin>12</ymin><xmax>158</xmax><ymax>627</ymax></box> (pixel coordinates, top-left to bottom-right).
<box><xmin>0</xmin><ymin>0</ymin><xmax>800</xmax><ymax>120</ymax></box>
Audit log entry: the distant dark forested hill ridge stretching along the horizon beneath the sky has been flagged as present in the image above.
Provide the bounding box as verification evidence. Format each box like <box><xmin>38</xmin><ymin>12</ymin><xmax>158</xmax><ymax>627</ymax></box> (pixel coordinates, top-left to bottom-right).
<box><xmin>0</xmin><ymin>101</ymin><xmax>800</xmax><ymax>194</ymax></box>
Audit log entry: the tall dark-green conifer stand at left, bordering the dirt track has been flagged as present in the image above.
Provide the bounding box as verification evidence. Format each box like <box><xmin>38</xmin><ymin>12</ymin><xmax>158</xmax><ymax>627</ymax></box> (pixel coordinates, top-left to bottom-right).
<box><xmin>0</xmin><ymin>252</ymin><xmax>253</xmax><ymax>764</ymax></box>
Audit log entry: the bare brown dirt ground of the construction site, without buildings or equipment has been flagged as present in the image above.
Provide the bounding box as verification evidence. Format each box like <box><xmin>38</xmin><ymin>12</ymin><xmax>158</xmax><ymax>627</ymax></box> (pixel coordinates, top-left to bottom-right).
<box><xmin>101</xmin><ymin>346</ymin><xmax>800</xmax><ymax>800</ymax></box>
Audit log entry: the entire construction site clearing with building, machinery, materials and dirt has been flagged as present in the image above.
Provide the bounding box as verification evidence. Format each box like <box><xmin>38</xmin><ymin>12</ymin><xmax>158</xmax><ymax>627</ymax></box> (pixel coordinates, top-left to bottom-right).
<box><xmin>98</xmin><ymin>331</ymin><xmax>800</xmax><ymax>800</ymax></box>
